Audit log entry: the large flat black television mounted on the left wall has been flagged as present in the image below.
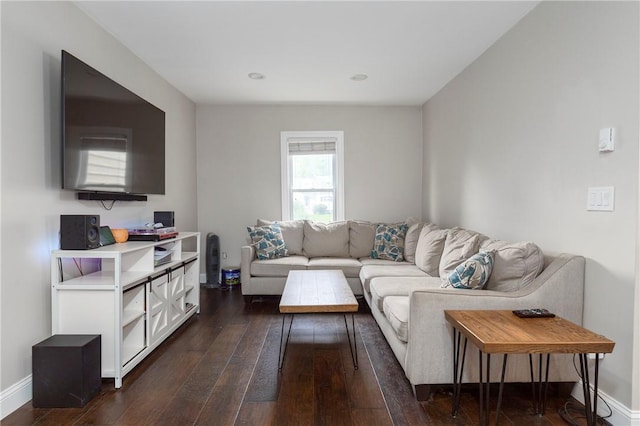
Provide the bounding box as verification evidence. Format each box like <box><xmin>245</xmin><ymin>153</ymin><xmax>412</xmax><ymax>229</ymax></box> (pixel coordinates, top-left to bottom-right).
<box><xmin>62</xmin><ymin>51</ymin><xmax>165</xmax><ymax>194</ymax></box>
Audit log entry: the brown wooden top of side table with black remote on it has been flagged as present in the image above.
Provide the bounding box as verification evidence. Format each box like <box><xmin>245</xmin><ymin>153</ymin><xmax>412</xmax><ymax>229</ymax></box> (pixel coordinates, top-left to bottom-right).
<box><xmin>444</xmin><ymin>310</ymin><xmax>615</xmax><ymax>354</ymax></box>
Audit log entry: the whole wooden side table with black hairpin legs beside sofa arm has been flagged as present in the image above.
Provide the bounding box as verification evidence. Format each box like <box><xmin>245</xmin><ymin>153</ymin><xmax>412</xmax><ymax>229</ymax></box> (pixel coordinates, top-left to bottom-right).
<box><xmin>444</xmin><ymin>310</ymin><xmax>615</xmax><ymax>426</ymax></box>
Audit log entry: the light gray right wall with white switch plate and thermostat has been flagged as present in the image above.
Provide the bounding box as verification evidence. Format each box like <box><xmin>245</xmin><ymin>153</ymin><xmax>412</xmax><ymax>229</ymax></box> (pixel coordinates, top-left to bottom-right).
<box><xmin>423</xmin><ymin>2</ymin><xmax>640</xmax><ymax>407</ymax></box>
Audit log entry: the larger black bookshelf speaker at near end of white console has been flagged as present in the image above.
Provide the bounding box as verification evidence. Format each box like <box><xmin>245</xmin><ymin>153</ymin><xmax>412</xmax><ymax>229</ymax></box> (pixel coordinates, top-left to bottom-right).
<box><xmin>60</xmin><ymin>214</ymin><xmax>100</xmax><ymax>250</ymax></box>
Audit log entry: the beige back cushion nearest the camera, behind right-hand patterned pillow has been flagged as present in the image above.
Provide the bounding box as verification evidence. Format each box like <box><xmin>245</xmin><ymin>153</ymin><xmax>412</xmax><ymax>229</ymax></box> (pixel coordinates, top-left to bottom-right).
<box><xmin>482</xmin><ymin>240</ymin><xmax>544</xmax><ymax>291</ymax></box>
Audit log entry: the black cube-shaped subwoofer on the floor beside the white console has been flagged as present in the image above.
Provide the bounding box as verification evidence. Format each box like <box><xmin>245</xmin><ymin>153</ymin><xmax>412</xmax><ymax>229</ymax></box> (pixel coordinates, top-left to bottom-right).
<box><xmin>32</xmin><ymin>334</ymin><xmax>102</xmax><ymax>408</ymax></box>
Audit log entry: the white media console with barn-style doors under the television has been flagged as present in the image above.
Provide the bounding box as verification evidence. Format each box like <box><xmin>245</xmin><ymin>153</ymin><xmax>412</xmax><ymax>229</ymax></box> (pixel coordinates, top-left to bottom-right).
<box><xmin>51</xmin><ymin>232</ymin><xmax>200</xmax><ymax>388</ymax></box>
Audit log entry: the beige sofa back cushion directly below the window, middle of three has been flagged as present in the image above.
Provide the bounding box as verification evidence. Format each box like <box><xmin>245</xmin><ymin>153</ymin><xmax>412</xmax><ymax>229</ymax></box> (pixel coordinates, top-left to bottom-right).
<box><xmin>302</xmin><ymin>220</ymin><xmax>349</xmax><ymax>257</ymax></box>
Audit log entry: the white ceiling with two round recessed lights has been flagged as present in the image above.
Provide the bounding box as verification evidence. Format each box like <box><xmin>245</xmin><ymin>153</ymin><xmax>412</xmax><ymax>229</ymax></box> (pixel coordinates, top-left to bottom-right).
<box><xmin>75</xmin><ymin>1</ymin><xmax>539</xmax><ymax>105</ymax></box>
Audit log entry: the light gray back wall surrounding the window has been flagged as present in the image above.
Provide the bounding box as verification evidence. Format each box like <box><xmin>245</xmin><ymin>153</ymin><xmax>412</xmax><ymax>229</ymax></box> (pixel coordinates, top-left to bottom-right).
<box><xmin>196</xmin><ymin>105</ymin><xmax>422</xmax><ymax>266</ymax></box>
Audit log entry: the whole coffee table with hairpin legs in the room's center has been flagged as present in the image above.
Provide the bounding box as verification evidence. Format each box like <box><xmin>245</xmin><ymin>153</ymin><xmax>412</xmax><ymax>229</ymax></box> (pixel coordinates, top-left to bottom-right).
<box><xmin>278</xmin><ymin>270</ymin><xmax>358</xmax><ymax>371</ymax></box>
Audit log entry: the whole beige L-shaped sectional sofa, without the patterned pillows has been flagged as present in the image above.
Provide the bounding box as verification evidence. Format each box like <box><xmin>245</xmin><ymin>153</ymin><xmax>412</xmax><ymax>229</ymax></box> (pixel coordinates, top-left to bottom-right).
<box><xmin>241</xmin><ymin>221</ymin><xmax>585</xmax><ymax>399</ymax></box>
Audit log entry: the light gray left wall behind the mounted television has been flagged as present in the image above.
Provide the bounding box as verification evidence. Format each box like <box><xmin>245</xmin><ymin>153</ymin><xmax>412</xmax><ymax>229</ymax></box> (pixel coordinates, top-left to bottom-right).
<box><xmin>0</xmin><ymin>2</ymin><xmax>197</xmax><ymax>402</ymax></box>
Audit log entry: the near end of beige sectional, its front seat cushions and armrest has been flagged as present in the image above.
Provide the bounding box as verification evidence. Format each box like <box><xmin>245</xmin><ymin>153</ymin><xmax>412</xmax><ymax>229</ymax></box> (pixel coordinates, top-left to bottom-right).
<box><xmin>365</xmin><ymin>254</ymin><xmax>585</xmax><ymax>399</ymax></box>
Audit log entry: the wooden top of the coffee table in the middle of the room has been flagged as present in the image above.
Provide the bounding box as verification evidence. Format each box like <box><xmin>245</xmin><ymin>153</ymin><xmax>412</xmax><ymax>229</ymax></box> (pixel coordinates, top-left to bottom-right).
<box><xmin>280</xmin><ymin>270</ymin><xmax>358</xmax><ymax>314</ymax></box>
